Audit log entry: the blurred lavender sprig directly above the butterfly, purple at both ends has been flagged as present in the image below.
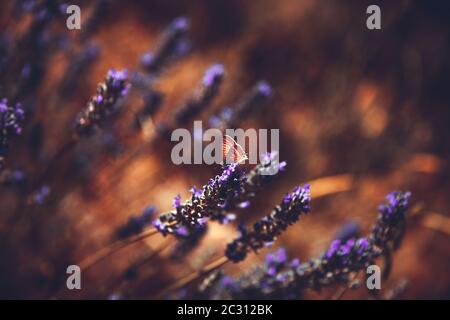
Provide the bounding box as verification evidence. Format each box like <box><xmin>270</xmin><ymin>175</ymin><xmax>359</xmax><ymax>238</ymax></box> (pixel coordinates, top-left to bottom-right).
<box><xmin>209</xmin><ymin>81</ymin><xmax>272</xmax><ymax>129</ymax></box>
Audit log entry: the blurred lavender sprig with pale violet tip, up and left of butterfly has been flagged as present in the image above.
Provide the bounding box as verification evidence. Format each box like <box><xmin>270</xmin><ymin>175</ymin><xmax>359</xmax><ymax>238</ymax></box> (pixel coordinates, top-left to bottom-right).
<box><xmin>174</xmin><ymin>64</ymin><xmax>225</xmax><ymax>125</ymax></box>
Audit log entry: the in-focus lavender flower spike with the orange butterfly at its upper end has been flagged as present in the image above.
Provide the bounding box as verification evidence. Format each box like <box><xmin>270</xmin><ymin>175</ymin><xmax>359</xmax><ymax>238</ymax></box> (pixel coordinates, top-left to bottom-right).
<box><xmin>153</xmin><ymin>163</ymin><xmax>243</xmax><ymax>237</ymax></box>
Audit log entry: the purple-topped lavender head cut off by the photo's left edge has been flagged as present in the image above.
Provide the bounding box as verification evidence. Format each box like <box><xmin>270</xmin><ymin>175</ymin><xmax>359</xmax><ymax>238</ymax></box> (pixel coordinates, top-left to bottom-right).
<box><xmin>0</xmin><ymin>99</ymin><xmax>25</xmax><ymax>170</ymax></box>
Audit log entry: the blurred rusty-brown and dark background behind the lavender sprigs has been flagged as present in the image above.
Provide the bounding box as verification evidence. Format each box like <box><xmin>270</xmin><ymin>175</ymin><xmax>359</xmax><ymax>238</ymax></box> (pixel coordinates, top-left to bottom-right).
<box><xmin>0</xmin><ymin>0</ymin><xmax>450</xmax><ymax>299</ymax></box>
